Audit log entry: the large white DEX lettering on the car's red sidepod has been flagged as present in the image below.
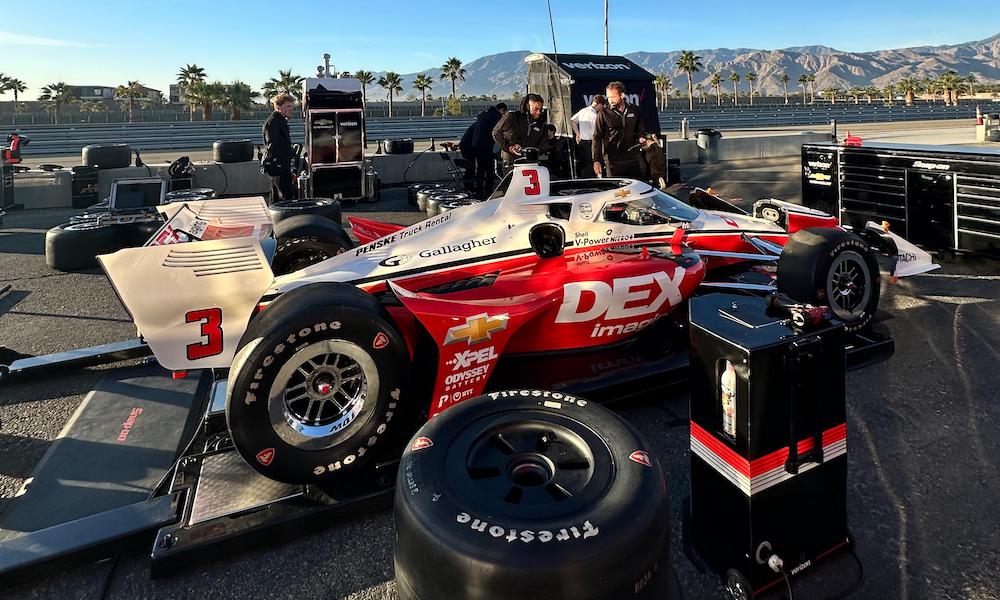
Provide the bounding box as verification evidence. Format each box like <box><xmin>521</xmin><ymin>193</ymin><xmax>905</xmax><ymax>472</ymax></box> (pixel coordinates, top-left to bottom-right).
<box><xmin>555</xmin><ymin>269</ymin><xmax>685</xmax><ymax>323</ymax></box>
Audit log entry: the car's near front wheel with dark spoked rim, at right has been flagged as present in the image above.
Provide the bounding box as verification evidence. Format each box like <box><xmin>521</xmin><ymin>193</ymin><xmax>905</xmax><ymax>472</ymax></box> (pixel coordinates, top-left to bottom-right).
<box><xmin>777</xmin><ymin>227</ymin><xmax>881</xmax><ymax>332</ymax></box>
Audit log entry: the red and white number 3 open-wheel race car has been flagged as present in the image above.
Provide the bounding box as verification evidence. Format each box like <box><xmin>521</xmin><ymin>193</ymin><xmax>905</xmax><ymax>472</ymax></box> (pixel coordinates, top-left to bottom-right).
<box><xmin>100</xmin><ymin>157</ymin><xmax>916</xmax><ymax>483</ymax></box>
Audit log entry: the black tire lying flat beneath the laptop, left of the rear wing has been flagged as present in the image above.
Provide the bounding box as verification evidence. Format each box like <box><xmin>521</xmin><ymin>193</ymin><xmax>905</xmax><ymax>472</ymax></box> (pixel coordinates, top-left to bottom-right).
<box><xmin>45</xmin><ymin>220</ymin><xmax>128</xmax><ymax>271</ymax></box>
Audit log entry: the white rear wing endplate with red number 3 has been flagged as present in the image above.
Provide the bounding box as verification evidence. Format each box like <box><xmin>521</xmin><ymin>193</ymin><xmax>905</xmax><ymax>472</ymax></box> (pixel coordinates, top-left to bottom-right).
<box><xmin>98</xmin><ymin>237</ymin><xmax>274</xmax><ymax>370</ymax></box>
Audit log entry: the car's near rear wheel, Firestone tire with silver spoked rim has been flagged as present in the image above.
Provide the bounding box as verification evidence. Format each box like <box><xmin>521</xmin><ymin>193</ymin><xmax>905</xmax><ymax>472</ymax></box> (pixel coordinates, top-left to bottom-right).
<box><xmin>226</xmin><ymin>283</ymin><xmax>410</xmax><ymax>483</ymax></box>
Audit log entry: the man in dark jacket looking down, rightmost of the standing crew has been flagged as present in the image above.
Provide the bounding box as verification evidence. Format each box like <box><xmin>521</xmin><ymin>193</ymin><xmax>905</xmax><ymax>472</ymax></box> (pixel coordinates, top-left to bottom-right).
<box><xmin>593</xmin><ymin>81</ymin><xmax>646</xmax><ymax>179</ymax></box>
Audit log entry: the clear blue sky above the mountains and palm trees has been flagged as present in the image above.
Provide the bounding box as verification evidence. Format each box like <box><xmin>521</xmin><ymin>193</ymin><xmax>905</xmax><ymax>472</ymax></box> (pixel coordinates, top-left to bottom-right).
<box><xmin>0</xmin><ymin>0</ymin><xmax>1000</xmax><ymax>100</ymax></box>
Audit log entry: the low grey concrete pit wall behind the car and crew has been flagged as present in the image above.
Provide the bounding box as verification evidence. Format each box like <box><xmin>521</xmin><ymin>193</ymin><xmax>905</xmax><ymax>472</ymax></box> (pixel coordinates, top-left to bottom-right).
<box><xmin>14</xmin><ymin>132</ymin><xmax>830</xmax><ymax>209</ymax></box>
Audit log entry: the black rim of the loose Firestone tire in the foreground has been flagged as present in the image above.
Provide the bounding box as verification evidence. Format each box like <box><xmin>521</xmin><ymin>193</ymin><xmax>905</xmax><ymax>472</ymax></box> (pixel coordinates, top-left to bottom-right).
<box><xmin>466</xmin><ymin>421</ymin><xmax>594</xmax><ymax>507</ymax></box>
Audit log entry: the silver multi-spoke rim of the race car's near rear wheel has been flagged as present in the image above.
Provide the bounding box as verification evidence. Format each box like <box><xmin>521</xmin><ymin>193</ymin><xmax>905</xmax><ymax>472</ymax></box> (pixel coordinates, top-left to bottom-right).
<box><xmin>268</xmin><ymin>340</ymin><xmax>378</xmax><ymax>450</ymax></box>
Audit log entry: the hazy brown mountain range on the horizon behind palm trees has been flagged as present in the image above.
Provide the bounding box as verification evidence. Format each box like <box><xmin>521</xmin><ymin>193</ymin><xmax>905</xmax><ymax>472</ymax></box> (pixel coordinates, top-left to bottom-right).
<box><xmin>368</xmin><ymin>34</ymin><xmax>1000</xmax><ymax>100</ymax></box>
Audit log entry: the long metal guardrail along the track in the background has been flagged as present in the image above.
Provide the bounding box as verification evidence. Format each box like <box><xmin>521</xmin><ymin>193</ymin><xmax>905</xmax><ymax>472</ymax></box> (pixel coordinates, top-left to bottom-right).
<box><xmin>7</xmin><ymin>103</ymin><xmax>975</xmax><ymax>156</ymax></box>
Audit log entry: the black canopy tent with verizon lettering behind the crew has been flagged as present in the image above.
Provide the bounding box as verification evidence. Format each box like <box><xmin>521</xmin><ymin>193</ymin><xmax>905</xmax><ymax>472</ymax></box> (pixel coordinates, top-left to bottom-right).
<box><xmin>524</xmin><ymin>54</ymin><xmax>660</xmax><ymax>136</ymax></box>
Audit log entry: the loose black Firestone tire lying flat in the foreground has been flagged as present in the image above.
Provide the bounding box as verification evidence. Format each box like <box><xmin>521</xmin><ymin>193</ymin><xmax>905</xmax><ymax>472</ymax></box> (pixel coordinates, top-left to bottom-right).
<box><xmin>394</xmin><ymin>390</ymin><xmax>671</xmax><ymax>600</ymax></box>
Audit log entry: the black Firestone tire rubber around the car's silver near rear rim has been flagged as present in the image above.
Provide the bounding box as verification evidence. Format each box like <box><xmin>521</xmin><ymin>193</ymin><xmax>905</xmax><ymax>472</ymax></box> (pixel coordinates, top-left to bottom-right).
<box><xmin>226</xmin><ymin>292</ymin><xmax>409</xmax><ymax>483</ymax></box>
